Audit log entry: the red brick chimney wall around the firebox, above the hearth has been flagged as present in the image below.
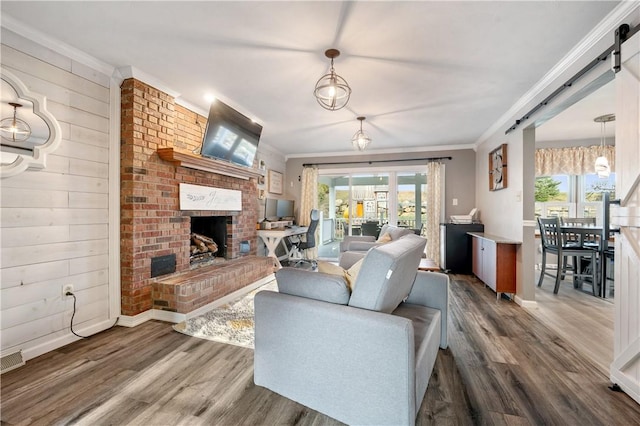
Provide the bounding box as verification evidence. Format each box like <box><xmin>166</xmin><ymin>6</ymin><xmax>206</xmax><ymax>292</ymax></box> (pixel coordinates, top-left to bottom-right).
<box><xmin>120</xmin><ymin>78</ymin><xmax>268</xmax><ymax>316</ymax></box>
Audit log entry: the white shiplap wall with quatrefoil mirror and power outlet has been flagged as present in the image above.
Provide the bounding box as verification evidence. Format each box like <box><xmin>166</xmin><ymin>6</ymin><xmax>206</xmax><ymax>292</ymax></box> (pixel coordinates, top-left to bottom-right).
<box><xmin>0</xmin><ymin>39</ymin><xmax>117</xmax><ymax>359</ymax></box>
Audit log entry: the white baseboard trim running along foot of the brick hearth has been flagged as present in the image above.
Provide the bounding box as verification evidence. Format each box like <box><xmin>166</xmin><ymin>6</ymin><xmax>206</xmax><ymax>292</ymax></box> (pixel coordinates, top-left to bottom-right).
<box><xmin>118</xmin><ymin>274</ymin><xmax>275</xmax><ymax>327</ymax></box>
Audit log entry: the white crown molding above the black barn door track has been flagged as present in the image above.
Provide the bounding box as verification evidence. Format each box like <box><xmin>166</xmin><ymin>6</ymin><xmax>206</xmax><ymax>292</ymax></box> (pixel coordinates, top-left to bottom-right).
<box><xmin>474</xmin><ymin>1</ymin><xmax>640</xmax><ymax>150</ymax></box>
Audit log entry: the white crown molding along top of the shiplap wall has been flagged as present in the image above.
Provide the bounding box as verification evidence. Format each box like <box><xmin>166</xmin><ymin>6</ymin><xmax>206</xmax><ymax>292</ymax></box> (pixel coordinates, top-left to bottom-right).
<box><xmin>2</xmin><ymin>13</ymin><xmax>115</xmax><ymax>76</ymax></box>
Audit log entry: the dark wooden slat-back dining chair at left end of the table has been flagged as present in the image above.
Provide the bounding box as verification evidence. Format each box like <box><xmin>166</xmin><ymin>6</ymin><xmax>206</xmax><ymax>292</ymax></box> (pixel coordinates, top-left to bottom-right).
<box><xmin>538</xmin><ymin>217</ymin><xmax>598</xmax><ymax>296</ymax></box>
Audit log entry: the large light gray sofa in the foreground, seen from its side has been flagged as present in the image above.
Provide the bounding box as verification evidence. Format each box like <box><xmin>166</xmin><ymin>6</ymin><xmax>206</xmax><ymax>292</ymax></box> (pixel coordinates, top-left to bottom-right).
<box><xmin>254</xmin><ymin>235</ymin><xmax>449</xmax><ymax>425</ymax></box>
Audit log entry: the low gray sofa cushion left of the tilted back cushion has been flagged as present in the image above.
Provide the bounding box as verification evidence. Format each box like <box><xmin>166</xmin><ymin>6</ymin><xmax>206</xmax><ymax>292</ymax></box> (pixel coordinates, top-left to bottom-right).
<box><xmin>276</xmin><ymin>268</ymin><xmax>351</xmax><ymax>305</ymax></box>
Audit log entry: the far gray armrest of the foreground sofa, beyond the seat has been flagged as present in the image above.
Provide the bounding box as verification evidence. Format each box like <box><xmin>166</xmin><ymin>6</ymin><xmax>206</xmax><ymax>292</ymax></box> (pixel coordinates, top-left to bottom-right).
<box><xmin>406</xmin><ymin>271</ymin><xmax>449</xmax><ymax>349</ymax></box>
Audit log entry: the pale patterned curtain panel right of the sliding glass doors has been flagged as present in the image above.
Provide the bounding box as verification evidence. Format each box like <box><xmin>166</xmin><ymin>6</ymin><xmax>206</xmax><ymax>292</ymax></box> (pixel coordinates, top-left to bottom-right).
<box><xmin>424</xmin><ymin>161</ymin><xmax>444</xmax><ymax>265</ymax></box>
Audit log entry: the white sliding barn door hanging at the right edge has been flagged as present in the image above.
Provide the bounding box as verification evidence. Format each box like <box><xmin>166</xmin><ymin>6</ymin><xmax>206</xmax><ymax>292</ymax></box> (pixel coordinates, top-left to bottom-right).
<box><xmin>611</xmin><ymin>29</ymin><xmax>640</xmax><ymax>403</ymax></box>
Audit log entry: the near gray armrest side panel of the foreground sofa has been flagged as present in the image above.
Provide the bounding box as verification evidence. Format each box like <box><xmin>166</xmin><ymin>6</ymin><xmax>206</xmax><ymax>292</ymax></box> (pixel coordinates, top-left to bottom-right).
<box><xmin>254</xmin><ymin>291</ymin><xmax>416</xmax><ymax>425</ymax></box>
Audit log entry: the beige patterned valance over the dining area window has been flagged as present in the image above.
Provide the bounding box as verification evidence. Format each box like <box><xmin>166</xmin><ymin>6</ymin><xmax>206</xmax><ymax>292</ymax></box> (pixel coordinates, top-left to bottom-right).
<box><xmin>536</xmin><ymin>145</ymin><xmax>616</xmax><ymax>177</ymax></box>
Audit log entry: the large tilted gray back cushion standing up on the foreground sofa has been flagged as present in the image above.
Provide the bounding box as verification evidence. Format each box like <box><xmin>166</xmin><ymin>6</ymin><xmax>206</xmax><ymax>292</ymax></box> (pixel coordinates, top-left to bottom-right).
<box><xmin>349</xmin><ymin>233</ymin><xmax>426</xmax><ymax>313</ymax></box>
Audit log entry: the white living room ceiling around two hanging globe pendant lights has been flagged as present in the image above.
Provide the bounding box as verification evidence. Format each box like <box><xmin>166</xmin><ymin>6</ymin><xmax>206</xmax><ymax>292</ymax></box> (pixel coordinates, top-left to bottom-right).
<box><xmin>0</xmin><ymin>0</ymin><xmax>618</xmax><ymax>156</ymax></box>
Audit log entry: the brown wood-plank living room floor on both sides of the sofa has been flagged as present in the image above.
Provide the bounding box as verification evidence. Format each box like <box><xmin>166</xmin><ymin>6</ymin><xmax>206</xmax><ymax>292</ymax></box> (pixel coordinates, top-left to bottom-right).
<box><xmin>1</xmin><ymin>275</ymin><xmax>640</xmax><ymax>425</ymax></box>
